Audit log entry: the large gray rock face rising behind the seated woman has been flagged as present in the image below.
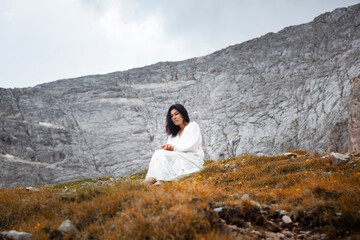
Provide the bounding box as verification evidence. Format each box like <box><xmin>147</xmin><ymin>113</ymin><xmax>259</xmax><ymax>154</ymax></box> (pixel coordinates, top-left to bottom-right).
<box><xmin>0</xmin><ymin>5</ymin><xmax>360</xmax><ymax>187</ymax></box>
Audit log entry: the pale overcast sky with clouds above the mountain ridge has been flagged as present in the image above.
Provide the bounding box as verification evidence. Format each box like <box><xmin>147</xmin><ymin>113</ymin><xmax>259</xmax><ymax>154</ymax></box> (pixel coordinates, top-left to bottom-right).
<box><xmin>0</xmin><ymin>0</ymin><xmax>360</xmax><ymax>88</ymax></box>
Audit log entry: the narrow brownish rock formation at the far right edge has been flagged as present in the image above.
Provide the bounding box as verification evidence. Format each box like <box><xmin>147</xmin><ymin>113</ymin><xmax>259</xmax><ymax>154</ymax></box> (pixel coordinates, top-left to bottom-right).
<box><xmin>349</xmin><ymin>75</ymin><xmax>360</xmax><ymax>152</ymax></box>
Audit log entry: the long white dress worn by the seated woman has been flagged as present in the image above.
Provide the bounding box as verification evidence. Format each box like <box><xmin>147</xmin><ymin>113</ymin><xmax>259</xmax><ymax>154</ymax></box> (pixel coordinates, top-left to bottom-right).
<box><xmin>146</xmin><ymin>122</ymin><xmax>204</xmax><ymax>181</ymax></box>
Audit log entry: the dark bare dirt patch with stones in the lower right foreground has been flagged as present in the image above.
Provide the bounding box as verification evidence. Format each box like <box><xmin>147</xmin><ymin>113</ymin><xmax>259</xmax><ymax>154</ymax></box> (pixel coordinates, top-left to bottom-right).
<box><xmin>217</xmin><ymin>202</ymin><xmax>360</xmax><ymax>239</ymax></box>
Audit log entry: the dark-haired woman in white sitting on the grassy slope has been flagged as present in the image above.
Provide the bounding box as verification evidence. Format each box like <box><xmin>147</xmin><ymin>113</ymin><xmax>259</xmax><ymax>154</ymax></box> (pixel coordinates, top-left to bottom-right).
<box><xmin>142</xmin><ymin>104</ymin><xmax>204</xmax><ymax>185</ymax></box>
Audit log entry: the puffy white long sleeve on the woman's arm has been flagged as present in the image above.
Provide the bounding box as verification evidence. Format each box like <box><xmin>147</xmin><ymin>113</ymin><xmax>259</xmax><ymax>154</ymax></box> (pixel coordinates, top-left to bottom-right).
<box><xmin>174</xmin><ymin>122</ymin><xmax>202</xmax><ymax>152</ymax></box>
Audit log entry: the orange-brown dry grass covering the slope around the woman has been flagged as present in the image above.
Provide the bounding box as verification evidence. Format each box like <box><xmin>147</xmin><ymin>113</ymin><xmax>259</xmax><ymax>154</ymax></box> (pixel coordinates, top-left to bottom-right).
<box><xmin>0</xmin><ymin>150</ymin><xmax>360</xmax><ymax>239</ymax></box>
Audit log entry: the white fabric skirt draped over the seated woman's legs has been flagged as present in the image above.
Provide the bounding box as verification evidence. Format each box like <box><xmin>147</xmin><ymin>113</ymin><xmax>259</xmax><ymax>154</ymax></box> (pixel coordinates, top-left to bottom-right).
<box><xmin>146</xmin><ymin>149</ymin><xmax>204</xmax><ymax>181</ymax></box>
